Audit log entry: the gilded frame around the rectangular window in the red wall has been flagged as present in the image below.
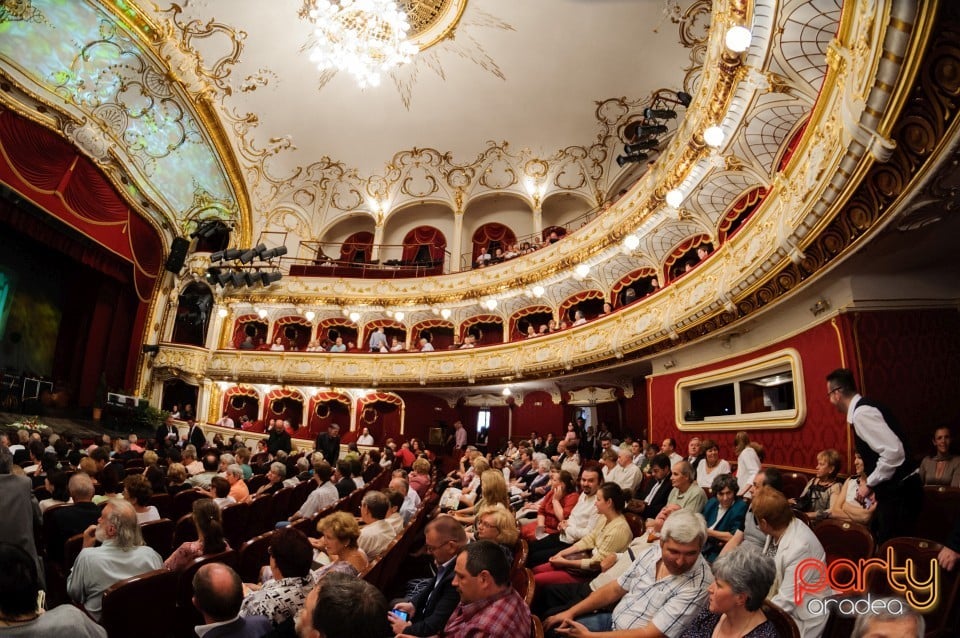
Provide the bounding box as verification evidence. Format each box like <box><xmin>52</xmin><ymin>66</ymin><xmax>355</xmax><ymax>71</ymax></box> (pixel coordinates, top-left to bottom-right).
<box><xmin>673</xmin><ymin>348</ymin><xmax>807</xmax><ymax>432</ymax></box>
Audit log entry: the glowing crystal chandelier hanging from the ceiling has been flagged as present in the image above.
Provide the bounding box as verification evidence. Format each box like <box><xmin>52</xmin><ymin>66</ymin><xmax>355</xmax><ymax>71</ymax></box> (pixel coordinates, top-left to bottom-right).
<box><xmin>310</xmin><ymin>0</ymin><xmax>418</xmax><ymax>88</ymax></box>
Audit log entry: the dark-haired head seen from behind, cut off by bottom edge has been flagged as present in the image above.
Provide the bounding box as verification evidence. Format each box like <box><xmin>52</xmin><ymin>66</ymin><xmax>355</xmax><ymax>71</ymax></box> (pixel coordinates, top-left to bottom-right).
<box><xmin>297</xmin><ymin>574</ymin><xmax>390</xmax><ymax>638</ymax></box>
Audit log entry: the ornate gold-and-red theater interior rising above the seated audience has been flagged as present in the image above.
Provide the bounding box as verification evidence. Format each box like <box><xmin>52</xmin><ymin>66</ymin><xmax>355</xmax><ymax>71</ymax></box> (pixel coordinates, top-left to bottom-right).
<box><xmin>0</xmin><ymin>0</ymin><xmax>960</xmax><ymax>636</ymax></box>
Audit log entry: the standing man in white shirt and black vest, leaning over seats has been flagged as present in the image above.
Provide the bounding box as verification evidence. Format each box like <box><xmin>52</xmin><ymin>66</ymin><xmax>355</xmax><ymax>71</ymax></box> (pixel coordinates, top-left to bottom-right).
<box><xmin>827</xmin><ymin>368</ymin><xmax>923</xmax><ymax>543</ymax></box>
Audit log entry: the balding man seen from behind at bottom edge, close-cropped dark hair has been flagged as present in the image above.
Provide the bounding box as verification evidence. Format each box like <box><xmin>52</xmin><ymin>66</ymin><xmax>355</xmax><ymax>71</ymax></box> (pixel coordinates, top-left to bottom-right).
<box><xmin>193</xmin><ymin>563</ymin><xmax>273</xmax><ymax>638</ymax></box>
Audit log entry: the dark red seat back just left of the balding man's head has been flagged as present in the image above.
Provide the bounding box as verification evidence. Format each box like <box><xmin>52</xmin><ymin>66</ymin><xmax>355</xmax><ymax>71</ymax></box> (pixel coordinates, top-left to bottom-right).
<box><xmin>100</xmin><ymin>568</ymin><xmax>179</xmax><ymax>638</ymax></box>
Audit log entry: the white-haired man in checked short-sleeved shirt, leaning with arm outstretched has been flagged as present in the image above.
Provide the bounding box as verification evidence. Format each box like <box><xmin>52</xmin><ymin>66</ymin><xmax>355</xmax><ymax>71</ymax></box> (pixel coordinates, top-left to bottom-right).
<box><xmin>544</xmin><ymin>510</ymin><xmax>713</xmax><ymax>636</ymax></box>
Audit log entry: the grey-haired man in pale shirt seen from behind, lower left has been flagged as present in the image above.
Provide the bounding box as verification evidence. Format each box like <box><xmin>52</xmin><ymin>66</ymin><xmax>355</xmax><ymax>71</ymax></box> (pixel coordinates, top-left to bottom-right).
<box><xmin>67</xmin><ymin>498</ymin><xmax>163</xmax><ymax>621</ymax></box>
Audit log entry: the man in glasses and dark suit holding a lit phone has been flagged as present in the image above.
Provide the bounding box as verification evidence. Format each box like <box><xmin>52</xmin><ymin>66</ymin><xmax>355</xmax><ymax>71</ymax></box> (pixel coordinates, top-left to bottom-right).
<box><xmin>387</xmin><ymin>515</ymin><xmax>467</xmax><ymax>636</ymax></box>
